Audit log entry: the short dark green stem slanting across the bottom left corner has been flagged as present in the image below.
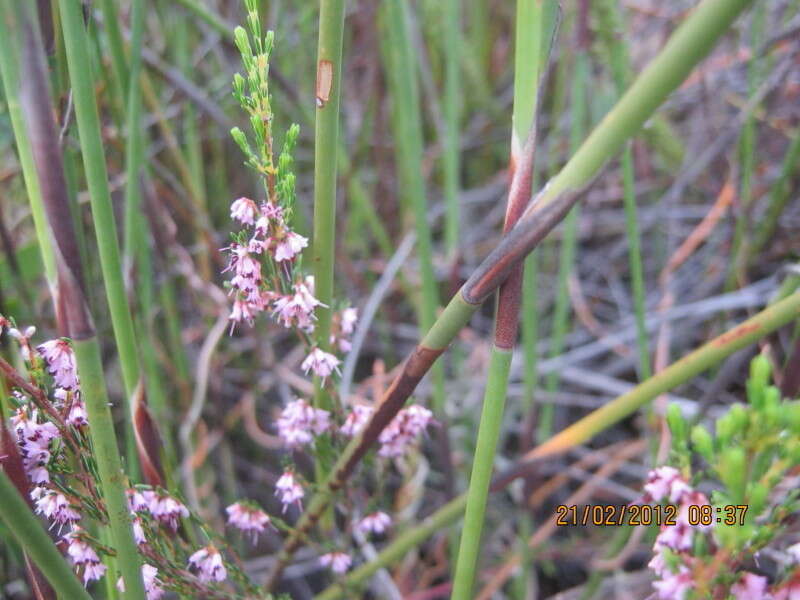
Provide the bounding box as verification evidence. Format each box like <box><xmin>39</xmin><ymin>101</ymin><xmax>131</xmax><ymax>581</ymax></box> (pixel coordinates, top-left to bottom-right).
<box><xmin>0</xmin><ymin>469</ymin><xmax>91</xmax><ymax>600</ymax></box>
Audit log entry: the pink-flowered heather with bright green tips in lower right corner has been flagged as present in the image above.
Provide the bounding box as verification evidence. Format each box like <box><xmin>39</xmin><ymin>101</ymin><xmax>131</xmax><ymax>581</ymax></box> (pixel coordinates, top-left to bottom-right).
<box><xmin>643</xmin><ymin>354</ymin><xmax>800</xmax><ymax>600</ymax></box>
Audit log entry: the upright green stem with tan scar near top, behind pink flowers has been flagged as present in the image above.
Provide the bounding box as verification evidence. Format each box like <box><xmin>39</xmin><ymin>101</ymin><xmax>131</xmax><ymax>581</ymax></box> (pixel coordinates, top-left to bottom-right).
<box><xmin>312</xmin><ymin>0</ymin><xmax>345</xmax><ymax>410</ymax></box>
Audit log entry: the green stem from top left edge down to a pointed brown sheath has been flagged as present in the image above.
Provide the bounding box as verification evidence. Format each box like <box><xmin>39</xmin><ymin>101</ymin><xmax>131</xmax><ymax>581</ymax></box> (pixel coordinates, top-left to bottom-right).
<box><xmin>59</xmin><ymin>0</ymin><xmax>140</xmax><ymax>404</ymax></box>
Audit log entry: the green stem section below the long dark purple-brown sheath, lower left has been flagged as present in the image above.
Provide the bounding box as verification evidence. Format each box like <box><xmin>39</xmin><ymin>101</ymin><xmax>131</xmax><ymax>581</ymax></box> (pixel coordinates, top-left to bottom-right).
<box><xmin>73</xmin><ymin>337</ymin><xmax>144</xmax><ymax>599</ymax></box>
